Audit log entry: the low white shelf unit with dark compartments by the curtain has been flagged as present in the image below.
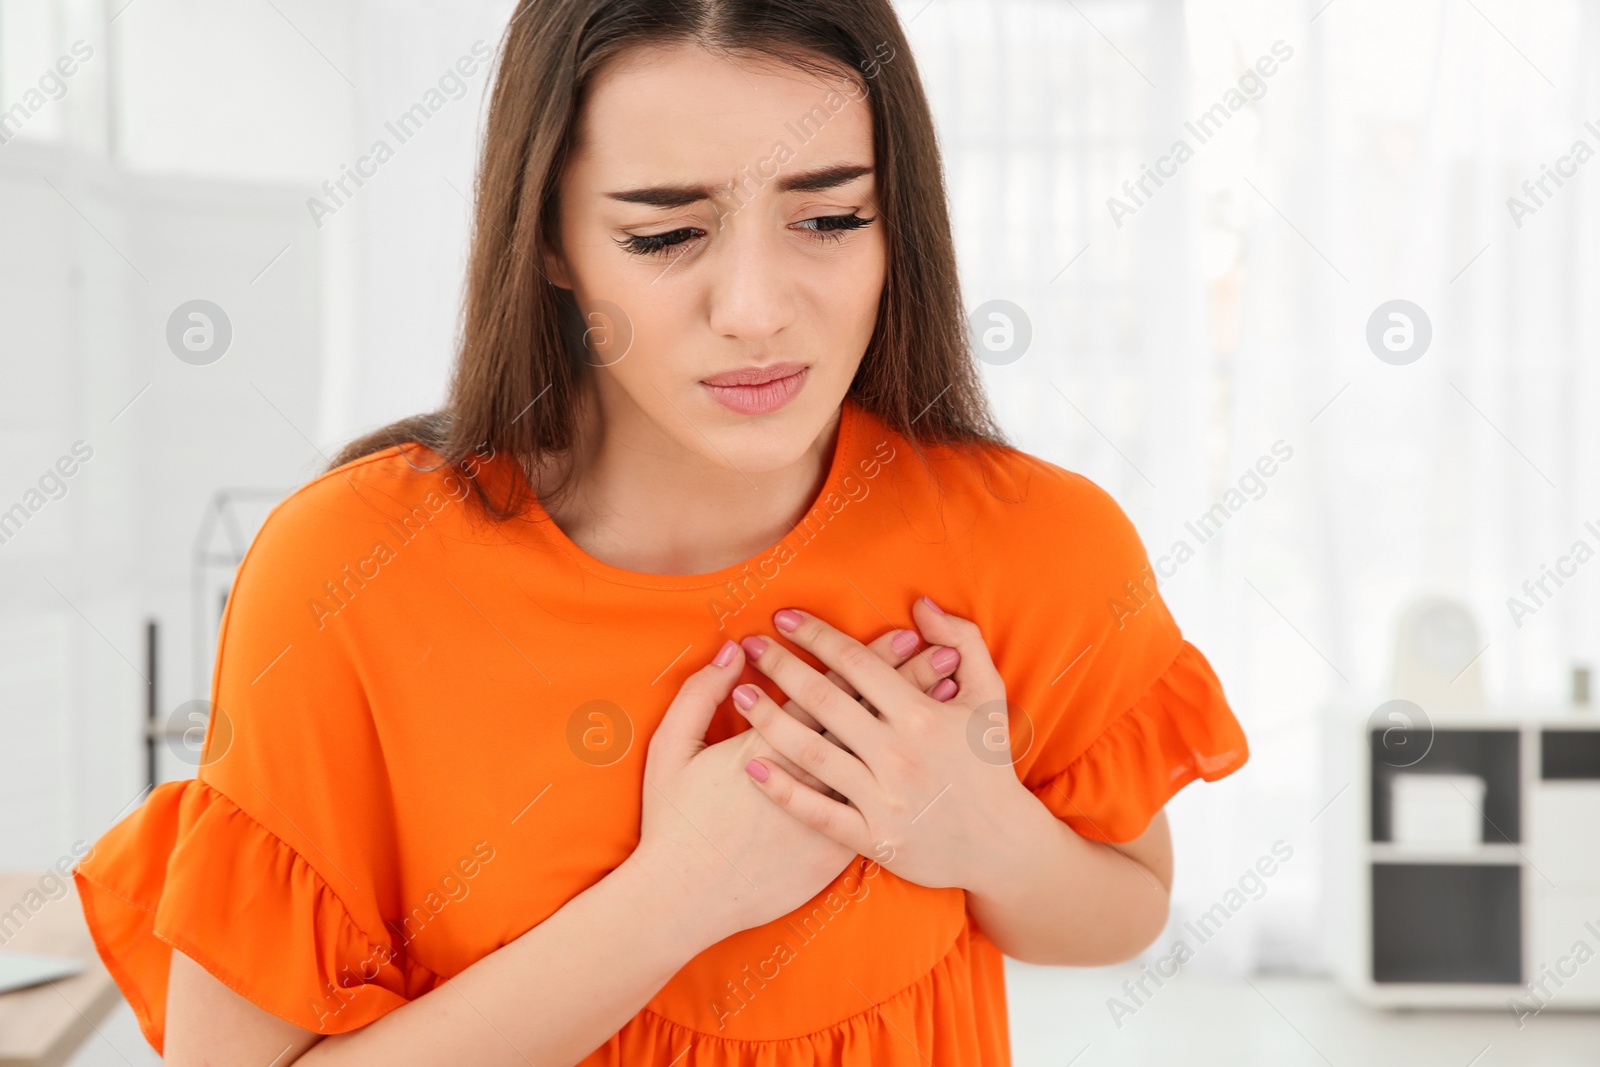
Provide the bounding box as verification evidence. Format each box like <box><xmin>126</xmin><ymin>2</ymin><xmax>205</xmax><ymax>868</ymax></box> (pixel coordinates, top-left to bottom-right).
<box><xmin>1320</xmin><ymin>709</ymin><xmax>1600</xmax><ymax>1011</ymax></box>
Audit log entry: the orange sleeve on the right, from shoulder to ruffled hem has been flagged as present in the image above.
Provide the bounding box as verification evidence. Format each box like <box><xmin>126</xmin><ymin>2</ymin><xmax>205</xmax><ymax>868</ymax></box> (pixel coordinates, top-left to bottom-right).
<box><xmin>997</xmin><ymin>458</ymin><xmax>1250</xmax><ymax>841</ymax></box>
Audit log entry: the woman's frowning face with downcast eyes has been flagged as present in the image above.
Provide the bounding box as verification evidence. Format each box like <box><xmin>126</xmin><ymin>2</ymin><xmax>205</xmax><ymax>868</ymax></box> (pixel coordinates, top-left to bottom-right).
<box><xmin>547</xmin><ymin>45</ymin><xmax>885</xmax><ymax>475</ymax></box>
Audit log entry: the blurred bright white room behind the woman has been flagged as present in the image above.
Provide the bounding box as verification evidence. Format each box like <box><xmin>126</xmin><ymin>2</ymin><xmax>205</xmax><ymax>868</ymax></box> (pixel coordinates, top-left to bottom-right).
<box><xmin>0</xmin><ymin>0</ymin><xmax>1600</xmax><ymax>1067</ymax></box>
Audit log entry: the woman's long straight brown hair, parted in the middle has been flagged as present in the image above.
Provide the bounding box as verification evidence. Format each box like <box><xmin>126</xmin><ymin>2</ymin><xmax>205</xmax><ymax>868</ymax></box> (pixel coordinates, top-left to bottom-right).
<box><xmin>333</xmin><ymin>0</ymin><xmax>1003</xmax><ymax>517</ymax></box>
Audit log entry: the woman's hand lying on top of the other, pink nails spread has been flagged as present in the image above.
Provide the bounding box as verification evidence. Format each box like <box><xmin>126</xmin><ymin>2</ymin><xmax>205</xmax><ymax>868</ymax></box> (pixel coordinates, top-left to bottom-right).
<box><xmin>733</xmin><ymin>597</ymin><xmax>1038</xmax><ymax>888</ymax></box>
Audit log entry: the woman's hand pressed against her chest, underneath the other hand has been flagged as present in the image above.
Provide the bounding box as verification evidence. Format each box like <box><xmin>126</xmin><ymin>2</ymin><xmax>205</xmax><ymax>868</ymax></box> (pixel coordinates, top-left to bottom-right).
<box><xmin>629</xmin><ymin>630</ymin><xmax>955</xmax><ymax>944</ymax></box>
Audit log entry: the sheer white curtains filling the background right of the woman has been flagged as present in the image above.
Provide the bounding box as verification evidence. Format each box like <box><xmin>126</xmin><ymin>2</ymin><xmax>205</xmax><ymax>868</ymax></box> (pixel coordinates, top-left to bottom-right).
<box><xmin>902</xmin><ymin>0</ymin><xmax>1600</xmax><ymax>973</ymax></box>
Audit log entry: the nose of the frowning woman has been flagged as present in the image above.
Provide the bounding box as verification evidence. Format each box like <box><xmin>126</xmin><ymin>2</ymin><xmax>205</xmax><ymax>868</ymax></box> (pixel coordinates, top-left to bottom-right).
<box><xmin>706</xmin><ymin>205</ymin><xmax>795</xmax><ymax>341</ymax></box>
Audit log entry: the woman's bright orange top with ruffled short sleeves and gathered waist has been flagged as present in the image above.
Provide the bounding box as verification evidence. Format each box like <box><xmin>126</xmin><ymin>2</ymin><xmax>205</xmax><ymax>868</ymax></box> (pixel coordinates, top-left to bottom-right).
<box><xmin>75</xmin><ymin>400</ymin><xmax>1248</xmax><ymax>1067</ymax></box>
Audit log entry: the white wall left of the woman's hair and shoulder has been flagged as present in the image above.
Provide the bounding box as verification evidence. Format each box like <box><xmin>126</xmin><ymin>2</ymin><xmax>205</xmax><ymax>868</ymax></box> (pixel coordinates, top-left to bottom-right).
<box><xmin>0</xmin><ymin>0</ymin><xmax>507</xmax><ymax>867</ymax></box>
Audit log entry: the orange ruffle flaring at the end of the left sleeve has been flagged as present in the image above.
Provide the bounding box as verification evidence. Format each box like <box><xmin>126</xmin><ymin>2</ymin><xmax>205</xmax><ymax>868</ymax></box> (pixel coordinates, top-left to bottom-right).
<box><xmin>75</xmin><ymin>779</ymin><xmax>432</xmax><ymax>1053</ymax></box>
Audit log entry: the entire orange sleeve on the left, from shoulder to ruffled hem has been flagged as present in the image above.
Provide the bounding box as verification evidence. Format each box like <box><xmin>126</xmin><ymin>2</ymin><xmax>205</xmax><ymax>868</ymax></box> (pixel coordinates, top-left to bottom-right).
<box><xmin>74</xmin><ymin>463</ymin><xmax>438</xmax><ymax>1053</ymax></box>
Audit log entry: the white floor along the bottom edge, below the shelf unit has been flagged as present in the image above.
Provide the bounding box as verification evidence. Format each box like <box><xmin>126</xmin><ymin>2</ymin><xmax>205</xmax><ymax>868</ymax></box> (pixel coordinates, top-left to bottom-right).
<box><xmin>59</xmin><ymin>961</ymin><xmax>1600</xmax><ymax>1067</ymax></box>
